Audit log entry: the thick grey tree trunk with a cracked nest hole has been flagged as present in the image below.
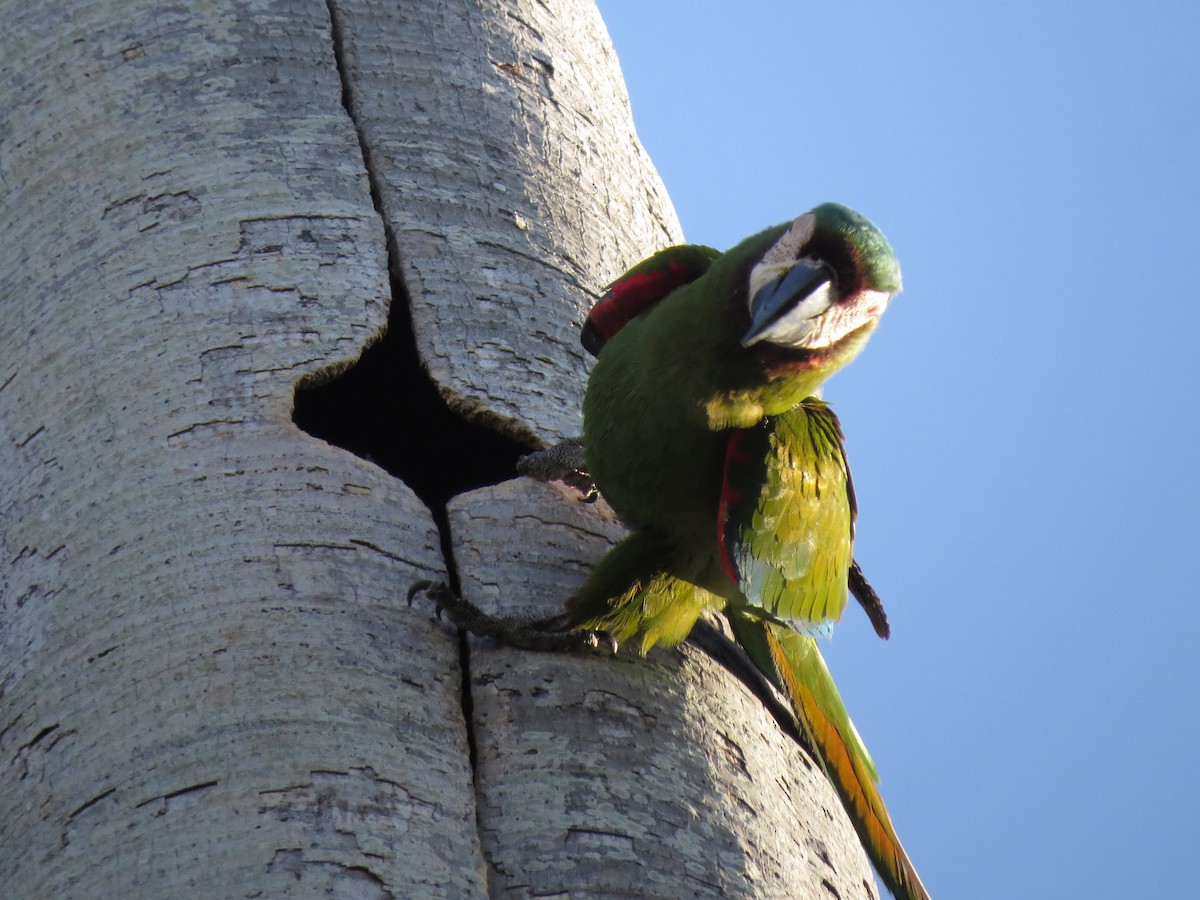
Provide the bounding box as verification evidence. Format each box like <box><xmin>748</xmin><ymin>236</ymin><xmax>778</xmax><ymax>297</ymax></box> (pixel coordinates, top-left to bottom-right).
<box><xmin>0</xmin><ymin>0</ymin><xmax>874</xmax><ymax>898</ymax></box>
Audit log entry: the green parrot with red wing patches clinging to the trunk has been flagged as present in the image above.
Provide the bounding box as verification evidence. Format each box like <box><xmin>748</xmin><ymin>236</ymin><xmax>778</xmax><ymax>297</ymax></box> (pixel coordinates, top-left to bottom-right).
<box><xmin>420</xmin><ymin>204</ymin><xmax>929</xmax><ymax>900</ymax></box>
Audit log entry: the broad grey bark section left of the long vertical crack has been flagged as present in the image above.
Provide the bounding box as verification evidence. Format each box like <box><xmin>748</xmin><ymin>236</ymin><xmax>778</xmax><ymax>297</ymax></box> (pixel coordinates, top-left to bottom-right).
<box><xmin>0</xmin><ymin>2</ymin><xmax>484</xmax><ymax>898</ymax></box>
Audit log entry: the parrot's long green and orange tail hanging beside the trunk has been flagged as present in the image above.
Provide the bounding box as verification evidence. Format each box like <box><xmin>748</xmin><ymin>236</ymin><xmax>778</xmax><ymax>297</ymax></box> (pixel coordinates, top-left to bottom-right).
<box><xmin>731</xmin><ymin>616</ymin><xmax>929</xmax><ymax>900</ymax></box>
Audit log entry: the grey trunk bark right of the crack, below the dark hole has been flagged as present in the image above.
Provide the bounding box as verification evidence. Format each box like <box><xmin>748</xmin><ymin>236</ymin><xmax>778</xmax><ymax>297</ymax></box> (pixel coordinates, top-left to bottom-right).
<box><xmin>450</xmin><ymin>480</ymin><xmax>875</xmax><ymax>898</ymax></box>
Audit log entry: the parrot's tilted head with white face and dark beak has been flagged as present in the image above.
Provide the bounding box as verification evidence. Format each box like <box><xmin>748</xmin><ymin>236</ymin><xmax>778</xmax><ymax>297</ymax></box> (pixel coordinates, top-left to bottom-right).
<box><xmin>739</xmin><ymin>203</ymin><xmax>900</xmax><ymax>368</ymax></box>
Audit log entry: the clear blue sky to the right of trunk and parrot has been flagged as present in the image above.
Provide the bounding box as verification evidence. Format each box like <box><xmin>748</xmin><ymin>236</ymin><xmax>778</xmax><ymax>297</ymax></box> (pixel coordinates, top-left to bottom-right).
<box><xmin>599</xmin><ymin>0</ymin><xmax>1200</xmax><ymax>900</ymax></box>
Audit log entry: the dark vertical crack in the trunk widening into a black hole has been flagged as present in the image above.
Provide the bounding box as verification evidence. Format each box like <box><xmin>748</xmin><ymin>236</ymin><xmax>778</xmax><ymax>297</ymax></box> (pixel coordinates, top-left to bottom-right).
<box><xmin>300</xmin><ymin>0</ymin><xmax>506</xmax><ymax>883</ymax></box>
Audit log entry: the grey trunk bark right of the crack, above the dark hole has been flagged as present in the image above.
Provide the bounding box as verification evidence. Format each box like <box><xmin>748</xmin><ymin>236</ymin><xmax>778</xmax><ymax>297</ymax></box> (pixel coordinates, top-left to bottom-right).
<box><xmin>336</xmin><ymin>0</ymin><xmax>682</xmax><ymax>443</ymax></box>
